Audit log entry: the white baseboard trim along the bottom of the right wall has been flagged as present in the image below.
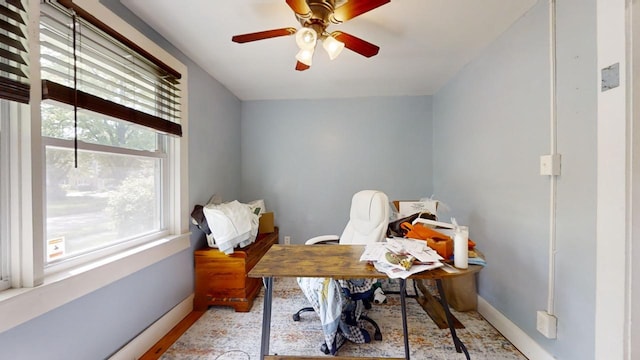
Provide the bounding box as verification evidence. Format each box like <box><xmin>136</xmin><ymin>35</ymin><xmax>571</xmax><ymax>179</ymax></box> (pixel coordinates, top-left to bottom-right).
<box><xmin>478</xmin><ymin>296</ymin><xmax>555</xmax><ymax>360</ymax></box>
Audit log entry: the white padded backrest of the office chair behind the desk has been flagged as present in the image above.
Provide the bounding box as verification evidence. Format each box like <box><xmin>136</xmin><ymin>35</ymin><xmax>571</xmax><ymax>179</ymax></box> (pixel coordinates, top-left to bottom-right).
<box><xmin>340</xmin><ymin>190</ymin><xmax>389</xmax><ymax>244</ymax></box>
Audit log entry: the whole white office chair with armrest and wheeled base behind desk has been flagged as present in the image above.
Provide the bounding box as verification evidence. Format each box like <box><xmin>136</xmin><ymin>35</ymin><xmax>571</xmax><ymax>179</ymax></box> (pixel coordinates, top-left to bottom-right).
<box><xmin>293</xmin><ymin>190</ymin><xmax>389</xmax><ymax>354</ymax></box>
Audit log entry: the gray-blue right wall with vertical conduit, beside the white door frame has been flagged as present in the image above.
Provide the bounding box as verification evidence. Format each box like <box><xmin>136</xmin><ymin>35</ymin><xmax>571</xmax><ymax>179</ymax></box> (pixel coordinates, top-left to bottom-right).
<box><xmin>433</xmin><ymin>1</ymin><xmax>596</xmax><ymax>359</ymax></box>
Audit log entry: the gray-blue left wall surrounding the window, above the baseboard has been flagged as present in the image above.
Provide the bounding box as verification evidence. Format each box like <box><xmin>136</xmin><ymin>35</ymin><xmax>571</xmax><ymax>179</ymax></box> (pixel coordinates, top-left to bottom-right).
<box><xmin>0</xmin><ymin>0</ymin><xmax>240</xmax><ymax>360</ymax></box>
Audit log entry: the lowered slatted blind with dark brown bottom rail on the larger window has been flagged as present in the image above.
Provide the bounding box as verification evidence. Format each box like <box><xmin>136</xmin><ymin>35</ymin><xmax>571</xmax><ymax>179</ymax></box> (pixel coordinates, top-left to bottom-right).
<box><xmin>40</xmin><ymin>1</ymin><xmax>182</xmax><ymax>136</ymax></box>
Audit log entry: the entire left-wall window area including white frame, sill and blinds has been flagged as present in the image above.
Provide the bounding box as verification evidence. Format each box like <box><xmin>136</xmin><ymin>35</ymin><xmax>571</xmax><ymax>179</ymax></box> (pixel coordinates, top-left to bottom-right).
<box><xmin>0</xmin><ymin>0</ymin><xmax>191</xmax><ymax>332</ymax></box>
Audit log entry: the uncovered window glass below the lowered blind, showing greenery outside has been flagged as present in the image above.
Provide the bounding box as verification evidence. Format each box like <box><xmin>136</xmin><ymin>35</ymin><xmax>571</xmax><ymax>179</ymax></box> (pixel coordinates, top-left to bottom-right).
<box><xmin>42</xmin><ymin>103</ymin><xmax>167</xmax><ymax>263</ymax></box>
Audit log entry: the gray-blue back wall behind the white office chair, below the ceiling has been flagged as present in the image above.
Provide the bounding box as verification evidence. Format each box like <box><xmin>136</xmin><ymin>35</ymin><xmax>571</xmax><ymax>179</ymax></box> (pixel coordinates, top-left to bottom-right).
<box><xmin>241</xmin><ymin>96</ymin><xmax>433</xmax><ymax>244</ymax></box>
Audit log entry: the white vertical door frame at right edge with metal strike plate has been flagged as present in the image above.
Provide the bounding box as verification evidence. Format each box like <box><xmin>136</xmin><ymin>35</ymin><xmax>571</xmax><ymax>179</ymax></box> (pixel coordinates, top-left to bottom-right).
<box><xmin>595</xmin><ymin>0</ymin><xmax>638</xmax><ymax>359</ymax></box>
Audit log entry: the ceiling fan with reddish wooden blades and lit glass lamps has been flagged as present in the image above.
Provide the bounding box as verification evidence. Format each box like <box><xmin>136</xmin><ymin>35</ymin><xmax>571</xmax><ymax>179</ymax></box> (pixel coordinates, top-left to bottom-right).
<box><xmin>231</xmin><ymin>0</ymin><xmax>391</xmax><ymax>71</ymax></box>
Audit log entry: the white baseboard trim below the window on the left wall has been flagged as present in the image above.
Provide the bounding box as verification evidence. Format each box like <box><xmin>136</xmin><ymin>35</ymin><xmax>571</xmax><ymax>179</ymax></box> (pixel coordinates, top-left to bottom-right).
<box><xmin>109</xmin><ymin>294</ymin><xmax>194</xmax><ymax>360</ymax></box>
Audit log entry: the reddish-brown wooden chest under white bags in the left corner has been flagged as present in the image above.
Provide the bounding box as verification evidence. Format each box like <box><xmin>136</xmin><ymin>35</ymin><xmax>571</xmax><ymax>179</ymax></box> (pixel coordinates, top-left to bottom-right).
<box><xmin>193</xmin><ymin>227</ymin><xmax>278</xmax><ymax>312</ymax></box>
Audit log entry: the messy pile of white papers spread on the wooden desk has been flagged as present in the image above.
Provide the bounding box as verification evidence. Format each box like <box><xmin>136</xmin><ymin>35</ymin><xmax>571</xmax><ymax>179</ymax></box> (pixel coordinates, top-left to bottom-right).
<box><xmin>360</xmin><ymin>238</ymin><xmax>443</xmax><ymax>279</ymax></box>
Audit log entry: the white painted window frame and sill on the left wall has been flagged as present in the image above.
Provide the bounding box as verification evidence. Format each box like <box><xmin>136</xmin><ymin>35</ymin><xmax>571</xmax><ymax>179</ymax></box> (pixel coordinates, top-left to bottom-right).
<box><xmin>0</xmin><ymin>0</ymin><xmax>191</xmax><ymax>332</ymax></box>
